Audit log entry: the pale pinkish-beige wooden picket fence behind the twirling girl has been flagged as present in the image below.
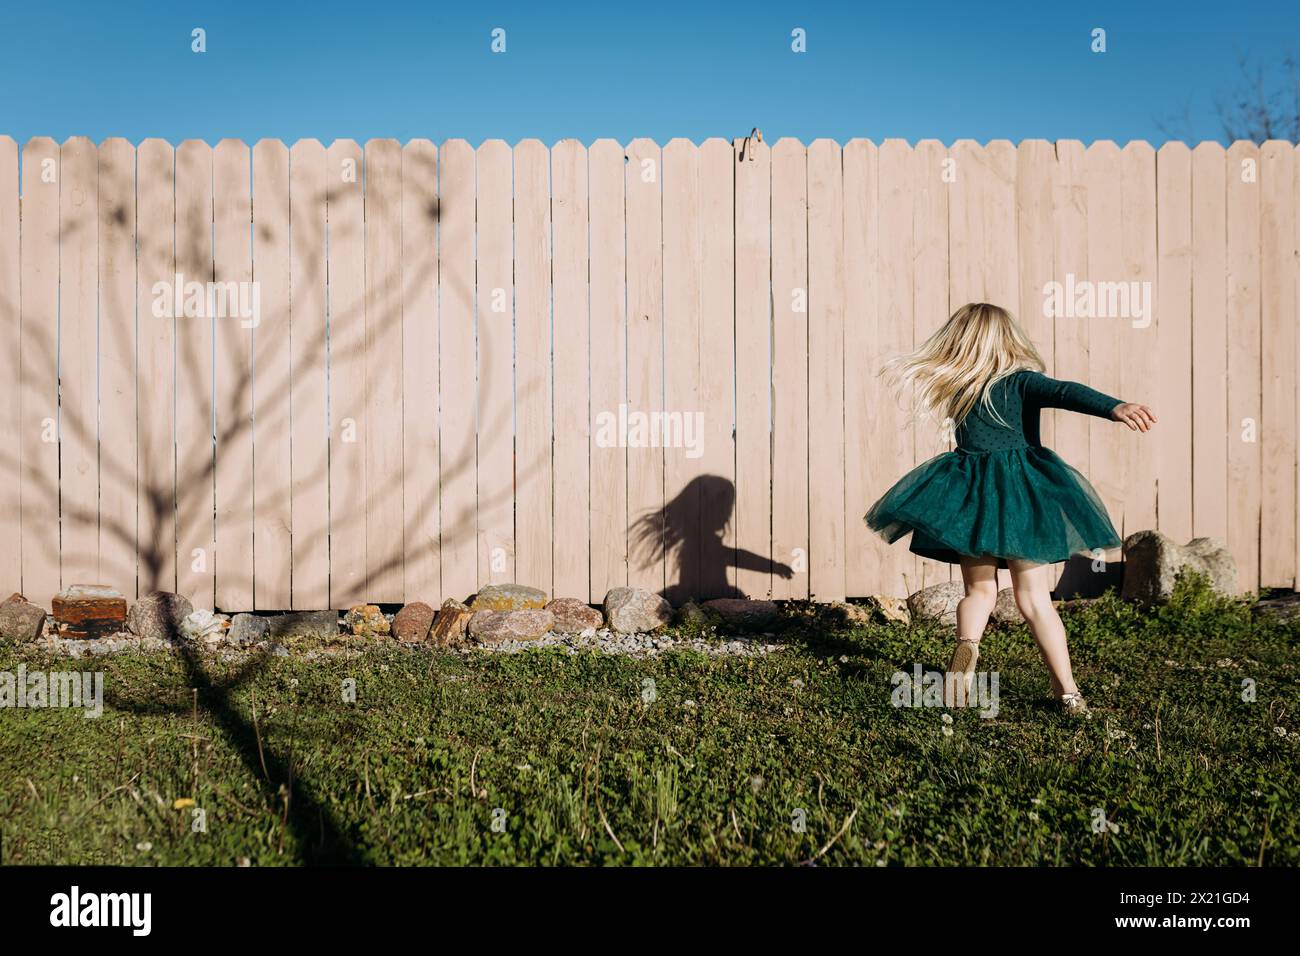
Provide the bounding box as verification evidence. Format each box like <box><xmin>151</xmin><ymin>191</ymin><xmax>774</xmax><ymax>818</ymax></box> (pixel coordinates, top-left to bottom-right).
<box><xmin>0</xmin><ymin>137</ymin><xmax>1300</xmax><ymax>610</ymax></box>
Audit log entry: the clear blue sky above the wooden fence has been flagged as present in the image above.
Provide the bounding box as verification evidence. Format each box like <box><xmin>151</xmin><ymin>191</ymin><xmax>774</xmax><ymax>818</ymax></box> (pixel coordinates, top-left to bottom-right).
<box><xmin>0</xmin><ymin>0</ymin><xmax>1300</xmax><ymax>143</ymax></box>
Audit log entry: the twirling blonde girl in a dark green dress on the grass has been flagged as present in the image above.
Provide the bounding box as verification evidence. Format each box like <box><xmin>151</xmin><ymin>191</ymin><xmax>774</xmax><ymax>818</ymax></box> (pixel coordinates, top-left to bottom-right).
<box><xmin>866</xmin><ymin>303</ymin><xmax>1156</xmax><ymax>714</ymax></box>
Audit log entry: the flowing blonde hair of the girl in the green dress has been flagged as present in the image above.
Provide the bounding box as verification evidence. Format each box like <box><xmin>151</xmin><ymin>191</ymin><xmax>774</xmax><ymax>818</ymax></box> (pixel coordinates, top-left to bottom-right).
<box><xmin>880</xmin><ymin>302</ymin><xmax>1045</xmax><ymax>428</ymax></box>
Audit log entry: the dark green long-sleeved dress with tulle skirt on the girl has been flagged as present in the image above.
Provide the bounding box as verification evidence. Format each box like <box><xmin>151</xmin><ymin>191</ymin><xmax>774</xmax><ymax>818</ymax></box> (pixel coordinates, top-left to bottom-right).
<box><xmin>866</xmin><ymin>369</ymin><xmax>1121</xmax><ymax>567</ymax></box>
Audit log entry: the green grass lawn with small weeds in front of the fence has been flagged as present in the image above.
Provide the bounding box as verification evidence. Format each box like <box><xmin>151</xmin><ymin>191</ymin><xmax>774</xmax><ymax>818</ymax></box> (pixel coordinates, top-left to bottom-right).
<box><xmin>0</xmin><ymin>574</ymin><xmax>1300</xmax><ymax>866</ymax></box>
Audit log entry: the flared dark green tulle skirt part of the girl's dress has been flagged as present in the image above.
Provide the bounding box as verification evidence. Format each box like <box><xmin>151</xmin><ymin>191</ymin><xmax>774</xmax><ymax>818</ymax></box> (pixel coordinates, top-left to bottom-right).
<box><xmin>866</xmin><ymin>446</ymin><xmax>1121</xmax><ymax>567</ymax></box>
